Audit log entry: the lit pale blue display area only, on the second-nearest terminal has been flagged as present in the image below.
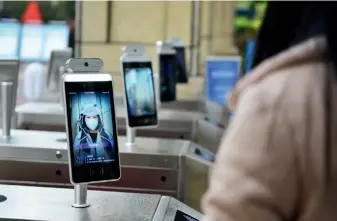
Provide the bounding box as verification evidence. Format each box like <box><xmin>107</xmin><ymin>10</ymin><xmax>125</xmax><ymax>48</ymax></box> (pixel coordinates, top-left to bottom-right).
<box><xmin>125</xmin><ymin>67</ymin><xmax>156</xmax><ymax>117</ymax></box>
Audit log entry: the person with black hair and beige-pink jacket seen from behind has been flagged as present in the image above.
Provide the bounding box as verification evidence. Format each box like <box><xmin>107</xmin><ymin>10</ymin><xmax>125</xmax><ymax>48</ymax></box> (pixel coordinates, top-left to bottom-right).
<box><xmin>202</xmin><ymin>1</ymin><xmax>337</xmax><ymax>221</ymax></box>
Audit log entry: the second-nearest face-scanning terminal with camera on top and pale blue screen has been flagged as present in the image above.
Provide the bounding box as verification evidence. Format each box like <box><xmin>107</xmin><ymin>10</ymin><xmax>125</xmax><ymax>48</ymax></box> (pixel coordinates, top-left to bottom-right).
<box><xmin>120</xmin><ymin>46</ymin><xmax>158</xmax><ymax>128</ymax></box>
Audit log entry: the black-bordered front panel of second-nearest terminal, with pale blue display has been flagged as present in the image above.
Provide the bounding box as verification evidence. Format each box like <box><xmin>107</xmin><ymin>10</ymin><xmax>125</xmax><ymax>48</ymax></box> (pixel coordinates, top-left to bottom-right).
<box><xmin>123</xmin><ymin>62</ymin><xmax>157</xmax><ymax>126</ymax></box>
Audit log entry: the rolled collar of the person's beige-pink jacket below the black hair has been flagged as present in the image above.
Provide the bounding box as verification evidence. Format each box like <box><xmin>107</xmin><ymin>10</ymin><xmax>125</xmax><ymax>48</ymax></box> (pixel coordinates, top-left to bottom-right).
<box><xmin>228</xmin><ymin>37</ymin><xmax>327</xmax><ymax>111</ymax></box>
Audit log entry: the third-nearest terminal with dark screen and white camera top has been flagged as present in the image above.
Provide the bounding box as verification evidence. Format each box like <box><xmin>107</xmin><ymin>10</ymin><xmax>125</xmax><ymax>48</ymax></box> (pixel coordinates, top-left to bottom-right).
<box><xmin>157</xmin><ymin>41</ymin><xmax>177</xmax><ymax>102</ymax></box>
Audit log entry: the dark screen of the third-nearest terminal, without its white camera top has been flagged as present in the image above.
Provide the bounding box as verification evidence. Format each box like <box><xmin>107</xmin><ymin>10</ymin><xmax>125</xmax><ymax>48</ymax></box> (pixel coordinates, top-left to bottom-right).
<box><xmin>160</xmin><ymin>54</ymin><xmax>177</xmax><ymax>102</ymax></box>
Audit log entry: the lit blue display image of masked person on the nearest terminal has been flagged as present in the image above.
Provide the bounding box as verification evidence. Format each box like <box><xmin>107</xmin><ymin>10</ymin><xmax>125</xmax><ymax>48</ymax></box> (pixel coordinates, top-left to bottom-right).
<box><xmin>70</xmin><ymin>92</ymin><xmax>115</xmax><ymax>165</ymax></box>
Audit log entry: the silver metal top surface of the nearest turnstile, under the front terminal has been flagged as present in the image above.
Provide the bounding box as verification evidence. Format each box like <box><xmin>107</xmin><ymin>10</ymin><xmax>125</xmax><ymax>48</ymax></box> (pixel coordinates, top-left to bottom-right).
<box><xmin>0</xmin><ymin>185</ymin><xmax>161</xmax><ymax>221</ymax></box>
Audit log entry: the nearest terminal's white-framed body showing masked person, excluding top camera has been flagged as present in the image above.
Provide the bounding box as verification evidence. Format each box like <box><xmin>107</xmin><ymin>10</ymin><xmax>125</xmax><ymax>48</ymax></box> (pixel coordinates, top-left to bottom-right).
<box><xmin>63</xmin><ymin>72</ymin><xmax>120</xmax><ymax>184</ymax></box>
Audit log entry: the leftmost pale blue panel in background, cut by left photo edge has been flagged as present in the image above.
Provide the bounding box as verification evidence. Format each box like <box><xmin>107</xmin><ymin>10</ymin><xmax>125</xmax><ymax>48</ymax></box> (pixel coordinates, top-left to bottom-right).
<box><xmin>0</xmin><ymin>21</ymin><xmax>21</xmax><ymax>59</ymax></box>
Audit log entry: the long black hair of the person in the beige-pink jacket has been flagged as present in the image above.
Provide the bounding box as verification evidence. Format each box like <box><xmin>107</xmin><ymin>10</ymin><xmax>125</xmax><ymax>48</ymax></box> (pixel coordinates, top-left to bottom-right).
<box><xmin>253</xmin><ymin>1</ymin><xmax>337</xmax><ymax>70</ymax></box>
